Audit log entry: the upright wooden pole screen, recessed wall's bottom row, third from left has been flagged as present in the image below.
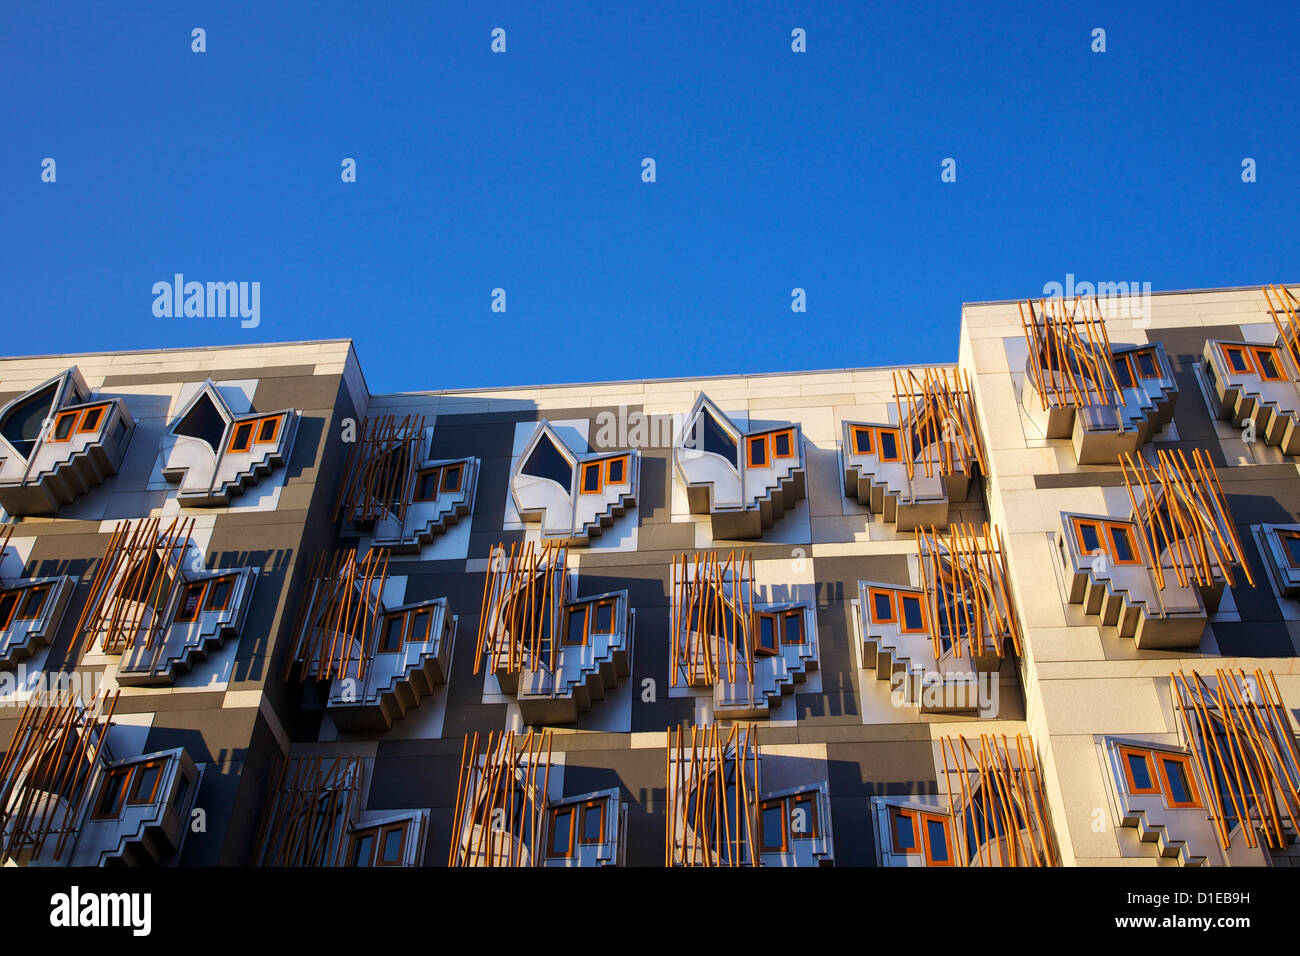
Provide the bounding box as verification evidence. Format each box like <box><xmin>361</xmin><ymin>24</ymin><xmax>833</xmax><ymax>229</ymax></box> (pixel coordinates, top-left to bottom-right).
<box><xmin>664</xmin><ymin>723</ymin><xmax>759</xmax><ymax>866</ymax></box>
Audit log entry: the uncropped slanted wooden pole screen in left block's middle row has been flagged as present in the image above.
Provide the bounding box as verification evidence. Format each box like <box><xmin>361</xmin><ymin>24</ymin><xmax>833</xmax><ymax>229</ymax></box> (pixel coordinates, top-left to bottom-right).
<box><xmin>75</xmin><ymin>518</ymin><xmax>194</xmax><ymax>654</ymax></box>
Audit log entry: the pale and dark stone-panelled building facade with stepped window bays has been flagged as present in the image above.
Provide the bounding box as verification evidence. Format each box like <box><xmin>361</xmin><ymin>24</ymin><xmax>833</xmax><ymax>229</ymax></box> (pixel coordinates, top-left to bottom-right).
<box><xmin>0</xmin><ymin>286</ymin><xmax>1300</xmax><ymax>866</ymax></box>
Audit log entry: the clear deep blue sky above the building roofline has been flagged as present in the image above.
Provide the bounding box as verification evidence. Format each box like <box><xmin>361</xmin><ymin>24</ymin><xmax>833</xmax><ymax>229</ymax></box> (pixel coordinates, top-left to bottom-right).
<box><xmin>0</xmin><ymin>0</ymin><xmax>1300</xmax><ymax>392</ymax></box>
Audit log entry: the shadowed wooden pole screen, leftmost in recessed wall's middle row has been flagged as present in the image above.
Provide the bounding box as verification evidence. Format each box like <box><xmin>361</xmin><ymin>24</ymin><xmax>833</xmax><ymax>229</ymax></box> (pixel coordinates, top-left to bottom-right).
<box><xmin>285</xmin><ymin>548</ymin><xmax>389</xmax><ymax>680</ymax></box>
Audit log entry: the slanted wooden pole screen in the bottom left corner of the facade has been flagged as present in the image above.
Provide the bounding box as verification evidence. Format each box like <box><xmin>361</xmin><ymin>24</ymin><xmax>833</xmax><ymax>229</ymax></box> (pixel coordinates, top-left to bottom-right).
<box><xmin>0</xmin><ymin>691</ymin><xmax>121</xmax><ymax>865</ymax></box>
